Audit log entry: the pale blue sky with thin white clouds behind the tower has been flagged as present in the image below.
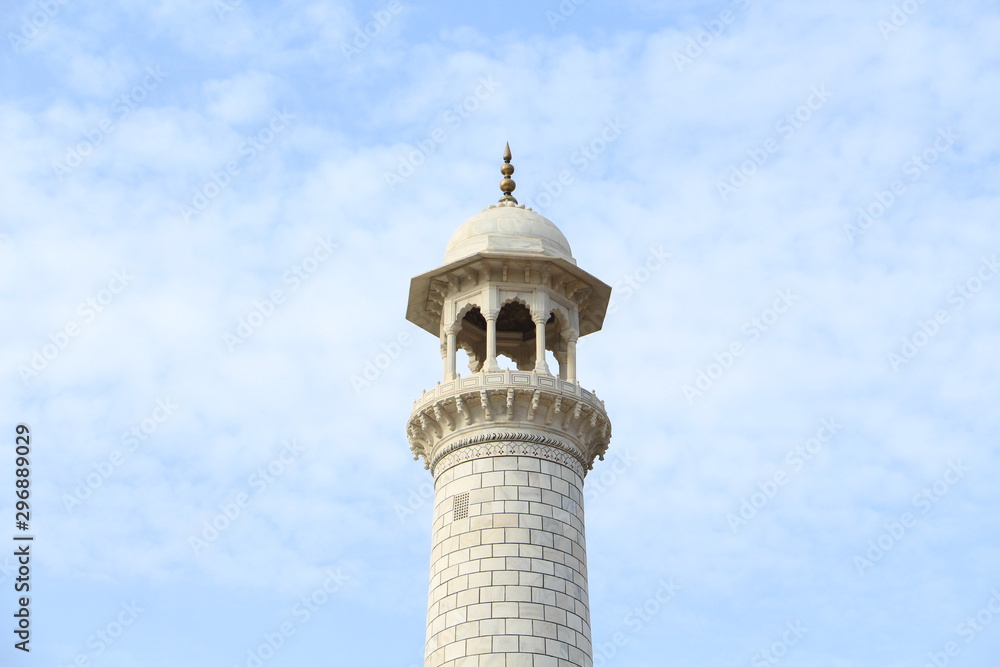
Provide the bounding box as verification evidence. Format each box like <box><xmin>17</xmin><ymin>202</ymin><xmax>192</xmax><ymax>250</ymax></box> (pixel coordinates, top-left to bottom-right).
<box><xmin>0</xmin><ymin>0</ymin><xmax>1000</xmax><ymax>667</ymax></box>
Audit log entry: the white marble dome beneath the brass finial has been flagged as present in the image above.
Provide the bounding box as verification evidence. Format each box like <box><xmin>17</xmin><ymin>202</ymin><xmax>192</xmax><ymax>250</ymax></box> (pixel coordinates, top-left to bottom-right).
<box><xmin>444</xmin><ymin>202</ymin><xmax>576</xmax><ymax>264</ymax></box>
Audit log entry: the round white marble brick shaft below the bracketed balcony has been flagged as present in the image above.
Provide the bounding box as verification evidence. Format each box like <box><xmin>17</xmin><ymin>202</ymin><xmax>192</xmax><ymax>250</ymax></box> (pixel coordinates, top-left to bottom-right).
<box><xmin>424</xmin><ymin>440</ymin><xmax>594</xmax><ymax>667</ymax></box>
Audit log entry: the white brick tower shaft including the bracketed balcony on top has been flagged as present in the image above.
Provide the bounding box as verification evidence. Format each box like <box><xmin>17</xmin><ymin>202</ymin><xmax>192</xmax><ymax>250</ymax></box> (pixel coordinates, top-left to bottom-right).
<box><xmin>407</xmin><ymin>372</ymin><xmax>611</xmax><ymax>667</ymax></box>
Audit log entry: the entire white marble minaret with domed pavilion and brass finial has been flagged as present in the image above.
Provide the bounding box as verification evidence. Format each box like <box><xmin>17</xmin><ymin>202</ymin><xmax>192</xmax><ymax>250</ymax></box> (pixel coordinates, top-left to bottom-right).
<box><xmin>406</xmin><ymin>145</ymin><xmax>611</xmax><ymax>667</ymax></box>
